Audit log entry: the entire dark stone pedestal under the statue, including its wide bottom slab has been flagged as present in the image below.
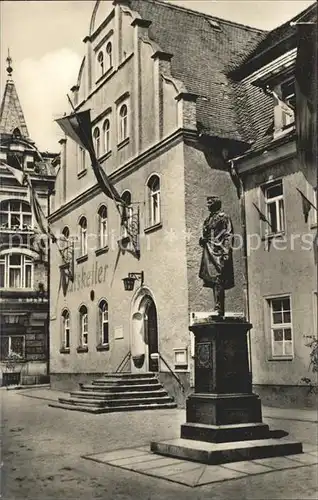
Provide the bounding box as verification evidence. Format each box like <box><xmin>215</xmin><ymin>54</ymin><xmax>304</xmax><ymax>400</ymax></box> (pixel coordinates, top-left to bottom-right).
<box><xmin>151</xmin><ymin>317</ymin><xmax>302</xmax><ymax>463</ymax></box>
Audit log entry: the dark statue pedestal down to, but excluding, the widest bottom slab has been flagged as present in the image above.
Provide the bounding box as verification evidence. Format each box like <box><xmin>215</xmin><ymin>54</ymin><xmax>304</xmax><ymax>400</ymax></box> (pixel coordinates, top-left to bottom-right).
<box><xmin>181</xmin><ymin>319</ymin><xmax>269</xmax><ymax>442</ymax></box>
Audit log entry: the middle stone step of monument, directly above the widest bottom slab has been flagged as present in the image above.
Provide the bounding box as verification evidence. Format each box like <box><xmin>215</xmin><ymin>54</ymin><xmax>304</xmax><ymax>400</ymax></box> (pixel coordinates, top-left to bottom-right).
<box><xmin>181</xmin><ymin>422</ymin><xmax>271</xmax><ymax>443</ymax></box>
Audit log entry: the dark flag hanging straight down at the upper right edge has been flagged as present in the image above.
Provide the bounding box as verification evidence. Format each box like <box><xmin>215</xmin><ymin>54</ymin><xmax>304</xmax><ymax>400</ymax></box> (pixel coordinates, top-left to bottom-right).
<box><xmin>295</xmin><ymin>23</ymin><xmax>317</xmax><ymax>167</ymax></box>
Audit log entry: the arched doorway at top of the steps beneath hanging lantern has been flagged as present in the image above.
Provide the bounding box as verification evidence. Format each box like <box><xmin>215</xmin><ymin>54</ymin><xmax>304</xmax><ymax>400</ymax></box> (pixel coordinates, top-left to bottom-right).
<box><xmin>131</xmin><ymin>287</ymin><xmax>159</xmax><ymax>372</ymax></box>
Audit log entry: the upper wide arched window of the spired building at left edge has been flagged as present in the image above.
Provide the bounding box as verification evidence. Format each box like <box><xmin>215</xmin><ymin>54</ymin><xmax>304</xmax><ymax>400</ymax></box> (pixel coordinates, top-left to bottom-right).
<box><xmin>0</xmin><ymin>200</ymin><xmax>33</xmax><ymax>231</ymax></box>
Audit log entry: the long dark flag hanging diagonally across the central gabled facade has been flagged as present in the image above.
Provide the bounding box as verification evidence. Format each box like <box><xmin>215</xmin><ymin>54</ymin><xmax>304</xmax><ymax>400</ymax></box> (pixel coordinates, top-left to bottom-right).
<box><xmin>56</xmin><ymin>110</ymin><xmax>123</xmax><ymax>204</ymax></box>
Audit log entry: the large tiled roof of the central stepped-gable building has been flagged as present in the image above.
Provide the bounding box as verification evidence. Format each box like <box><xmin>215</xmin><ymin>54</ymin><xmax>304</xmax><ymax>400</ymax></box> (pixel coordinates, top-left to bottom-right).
<box><xmin>129</xmin><ymin>0</ymin><xmax>268</xmax><ymax>144</ymax></box>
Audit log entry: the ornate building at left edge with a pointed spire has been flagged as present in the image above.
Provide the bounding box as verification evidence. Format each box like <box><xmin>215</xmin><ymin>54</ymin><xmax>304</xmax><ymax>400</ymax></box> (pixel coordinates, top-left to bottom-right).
<box><xmin>0</xmin><ymin>56</ymin><xmax>56</xmax><ymax>385</ymax></box>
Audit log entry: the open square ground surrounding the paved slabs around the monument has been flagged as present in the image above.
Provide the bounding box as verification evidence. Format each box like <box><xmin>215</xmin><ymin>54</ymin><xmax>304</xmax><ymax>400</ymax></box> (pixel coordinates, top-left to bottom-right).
<box><xmin>0</xmin><ymin>389</ymin><xmax>318</xmax><ymax>500</ymax></box>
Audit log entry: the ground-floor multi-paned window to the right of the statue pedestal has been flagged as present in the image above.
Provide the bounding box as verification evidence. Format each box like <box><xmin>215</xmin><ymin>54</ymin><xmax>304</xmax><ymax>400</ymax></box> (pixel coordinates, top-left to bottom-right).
<box><xmin>266</xmin><ymin>294</ymin><xmax>295</xmax><ymax>361</ymax></box>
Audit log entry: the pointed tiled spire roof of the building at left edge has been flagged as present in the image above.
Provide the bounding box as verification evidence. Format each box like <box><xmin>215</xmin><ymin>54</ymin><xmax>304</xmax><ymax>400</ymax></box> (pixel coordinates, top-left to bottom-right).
<box><xmin>0</xmin><ymin>72</ymin><xmax>29</xmax><ymax>137</ymax></box>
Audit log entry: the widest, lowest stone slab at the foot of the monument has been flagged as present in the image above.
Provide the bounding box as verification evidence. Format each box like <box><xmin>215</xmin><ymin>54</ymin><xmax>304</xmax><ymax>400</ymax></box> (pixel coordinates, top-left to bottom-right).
<box><xmin>150</xmin><ymin>438</ymin><xmax>303</xmax><ymax>465</ymax></box>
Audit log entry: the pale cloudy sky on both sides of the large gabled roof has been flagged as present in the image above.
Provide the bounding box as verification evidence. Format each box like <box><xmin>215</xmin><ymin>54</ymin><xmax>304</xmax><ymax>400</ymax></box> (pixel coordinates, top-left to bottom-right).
<box><xmin>0</xmin><ymin>0</ymin><xmax>313</xmax><ymax>152</ymax></box>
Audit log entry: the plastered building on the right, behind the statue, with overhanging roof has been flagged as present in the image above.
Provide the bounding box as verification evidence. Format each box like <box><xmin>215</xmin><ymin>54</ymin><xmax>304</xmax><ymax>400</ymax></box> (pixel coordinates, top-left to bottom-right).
<box><xmin>232</xmin><ymin>5</ymin><xmax>317</xmax><ymax>405</ymax></box>
